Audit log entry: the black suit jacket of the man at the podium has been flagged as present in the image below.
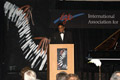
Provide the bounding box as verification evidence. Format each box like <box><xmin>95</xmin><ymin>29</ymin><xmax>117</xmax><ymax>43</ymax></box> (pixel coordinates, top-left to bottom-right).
<box><xmin>51</xmin><ymin>31</ymin><xmax>73</xmax><ymax>44</ymax></box>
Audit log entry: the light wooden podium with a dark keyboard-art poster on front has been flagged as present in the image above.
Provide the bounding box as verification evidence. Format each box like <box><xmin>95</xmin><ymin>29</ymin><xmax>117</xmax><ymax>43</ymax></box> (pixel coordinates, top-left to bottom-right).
<box><xmin>47</xmin><ymin>44</ymin><xmax>74</xmax><ymax>80</ymax></box>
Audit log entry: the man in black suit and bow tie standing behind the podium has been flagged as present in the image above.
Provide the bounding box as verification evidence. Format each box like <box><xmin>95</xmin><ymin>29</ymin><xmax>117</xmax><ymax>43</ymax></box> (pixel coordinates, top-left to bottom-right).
<box><xmin>51</xmin><ymin>23</ymin><xmax>72</xmax><ymax>44</ymax></box>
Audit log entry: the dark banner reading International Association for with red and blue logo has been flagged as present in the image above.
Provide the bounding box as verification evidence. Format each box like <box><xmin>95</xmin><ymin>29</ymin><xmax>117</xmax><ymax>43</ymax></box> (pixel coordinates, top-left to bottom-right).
<box><xmin>50</xmin><ymin>10</ymin><xmax>120</xmax><ymax>28</ymax></box>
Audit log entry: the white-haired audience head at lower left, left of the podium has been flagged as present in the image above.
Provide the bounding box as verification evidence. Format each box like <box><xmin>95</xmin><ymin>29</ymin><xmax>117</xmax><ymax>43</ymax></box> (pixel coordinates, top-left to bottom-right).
<box><xmin>24</xmin><ymin>70</ymin><xmax>37</xmax><ymax>80</ymax></box>
